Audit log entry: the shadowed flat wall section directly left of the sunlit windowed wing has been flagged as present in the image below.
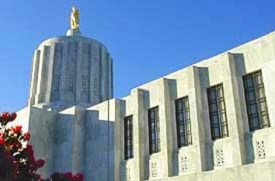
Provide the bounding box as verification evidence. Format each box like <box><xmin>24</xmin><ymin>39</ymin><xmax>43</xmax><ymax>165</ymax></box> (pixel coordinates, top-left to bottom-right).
<box><xmin>84</xmin><ymin>110</ymin><xmax>115</xmax><ymax>181</ymax></box>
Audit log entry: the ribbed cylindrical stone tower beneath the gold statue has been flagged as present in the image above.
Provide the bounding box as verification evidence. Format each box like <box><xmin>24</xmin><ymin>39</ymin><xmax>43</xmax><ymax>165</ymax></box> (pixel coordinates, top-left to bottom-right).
<box><xmin>29</xmin><ymin>29</ymin><xmax>113</xmax><ymax>106</ymax></box>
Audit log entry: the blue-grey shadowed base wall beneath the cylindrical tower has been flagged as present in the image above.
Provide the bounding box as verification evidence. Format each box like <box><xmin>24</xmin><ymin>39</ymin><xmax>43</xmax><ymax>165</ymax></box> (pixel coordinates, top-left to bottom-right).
<box><xmin>30</xmin><ymin>107</ymin><xmax>114</xmax><ymax>181</ymax></box>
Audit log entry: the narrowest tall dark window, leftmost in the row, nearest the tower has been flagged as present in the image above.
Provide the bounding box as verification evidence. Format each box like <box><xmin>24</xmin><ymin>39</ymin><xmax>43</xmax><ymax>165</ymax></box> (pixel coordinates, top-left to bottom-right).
<box><xmin>124</xmin><ymin>116</ymin><xmax>133</xmax><ymax>160</ymax></box>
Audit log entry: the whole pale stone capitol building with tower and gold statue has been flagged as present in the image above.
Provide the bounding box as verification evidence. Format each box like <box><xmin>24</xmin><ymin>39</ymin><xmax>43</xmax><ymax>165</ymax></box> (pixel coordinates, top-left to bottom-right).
<box><xmin>17</xmin><ymin>6</ymin><xmax>275</xmax><ymax>181</ymax></box>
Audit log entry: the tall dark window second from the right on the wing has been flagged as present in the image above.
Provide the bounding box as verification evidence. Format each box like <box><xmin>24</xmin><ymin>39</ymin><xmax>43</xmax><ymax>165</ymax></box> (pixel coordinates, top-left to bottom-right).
<box><xmin>207</xmin><ymin>84</ymin><xmax>228</xmax><ymax>140</ymax></box>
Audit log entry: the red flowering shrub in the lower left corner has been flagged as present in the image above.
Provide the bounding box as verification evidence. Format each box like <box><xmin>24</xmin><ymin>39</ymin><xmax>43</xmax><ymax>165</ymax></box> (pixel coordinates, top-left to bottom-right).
<box><xmin>0</xmin><ymin>112</ymin><xmax>84</xmax><ymax>181</ymax></box>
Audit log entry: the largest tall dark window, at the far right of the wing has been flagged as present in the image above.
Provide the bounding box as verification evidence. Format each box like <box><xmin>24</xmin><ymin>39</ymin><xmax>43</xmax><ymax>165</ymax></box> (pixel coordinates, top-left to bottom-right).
<box><xmin>243</xmin><ymin>71</ymin><xmax>270</xmax><ymax>131</ymax></box>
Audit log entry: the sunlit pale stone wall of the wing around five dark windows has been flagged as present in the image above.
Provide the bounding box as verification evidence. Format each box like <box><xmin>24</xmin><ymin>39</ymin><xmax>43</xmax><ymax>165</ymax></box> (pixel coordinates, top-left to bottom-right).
<box><xmin>113</xmin><ymin>30</ymin><xmax>275</xmax><ymax>181</ymax></box>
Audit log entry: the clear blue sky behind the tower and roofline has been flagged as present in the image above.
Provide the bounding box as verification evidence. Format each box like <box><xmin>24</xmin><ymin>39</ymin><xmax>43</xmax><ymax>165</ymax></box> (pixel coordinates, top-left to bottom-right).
<box><xmin>0</xmin><ymin>0</ymin><xmax>275</xmax><ymax>111</ymax></box>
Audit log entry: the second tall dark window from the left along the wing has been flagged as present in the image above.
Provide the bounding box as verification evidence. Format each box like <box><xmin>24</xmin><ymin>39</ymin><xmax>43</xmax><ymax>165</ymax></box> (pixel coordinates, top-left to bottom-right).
<box><xmin>148</xmin><ymin>107</ymin><xmax>160</xmax><ymax>154</ymax></box>
